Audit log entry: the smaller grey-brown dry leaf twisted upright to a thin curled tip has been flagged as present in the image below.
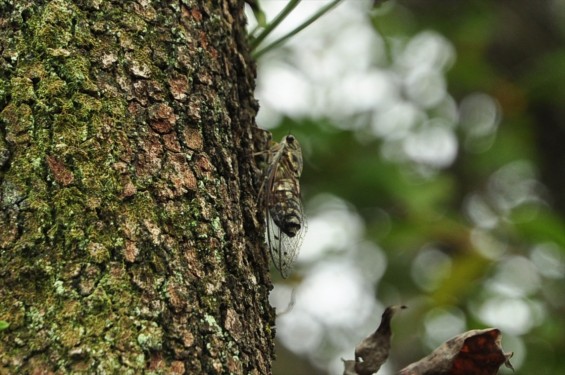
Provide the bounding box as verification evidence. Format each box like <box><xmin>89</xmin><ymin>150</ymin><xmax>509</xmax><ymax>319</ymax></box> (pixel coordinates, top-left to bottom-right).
<box><xmin>352</xmin><ymin>305</ymin><xmax>406</xmax><ymax>375</ymax></box>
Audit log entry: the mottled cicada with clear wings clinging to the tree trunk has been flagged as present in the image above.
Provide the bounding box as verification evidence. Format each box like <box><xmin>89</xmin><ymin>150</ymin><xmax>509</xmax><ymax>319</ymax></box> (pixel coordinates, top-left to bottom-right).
<box><xmin>261</xmin><ymin>134</ymin><xmax>306</xmax><ymax>278</ymax></box>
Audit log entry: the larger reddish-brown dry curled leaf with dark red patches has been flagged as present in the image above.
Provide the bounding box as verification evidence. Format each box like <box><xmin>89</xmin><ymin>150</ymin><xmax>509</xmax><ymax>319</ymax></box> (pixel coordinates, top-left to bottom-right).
<box><xmin>399</xmin><ymin>328</ymin><xmax>514</xmax><ymax>375</ymax></box>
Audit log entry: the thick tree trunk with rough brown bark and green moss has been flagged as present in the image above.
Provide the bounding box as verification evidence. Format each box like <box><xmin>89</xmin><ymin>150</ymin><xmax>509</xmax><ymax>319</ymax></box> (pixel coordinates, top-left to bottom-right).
<box><xmin>0</xmin><ymin>0</ymin><xmax>273</xmax><ymax>374</ymax></box>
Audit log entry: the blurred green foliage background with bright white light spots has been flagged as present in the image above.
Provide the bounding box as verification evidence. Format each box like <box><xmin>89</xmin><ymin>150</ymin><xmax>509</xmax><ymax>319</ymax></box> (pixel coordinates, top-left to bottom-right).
<box><xmin>249</xmin><ymin>0</ymin><xmax>565</xmax><ymax>375</ymax></box>
